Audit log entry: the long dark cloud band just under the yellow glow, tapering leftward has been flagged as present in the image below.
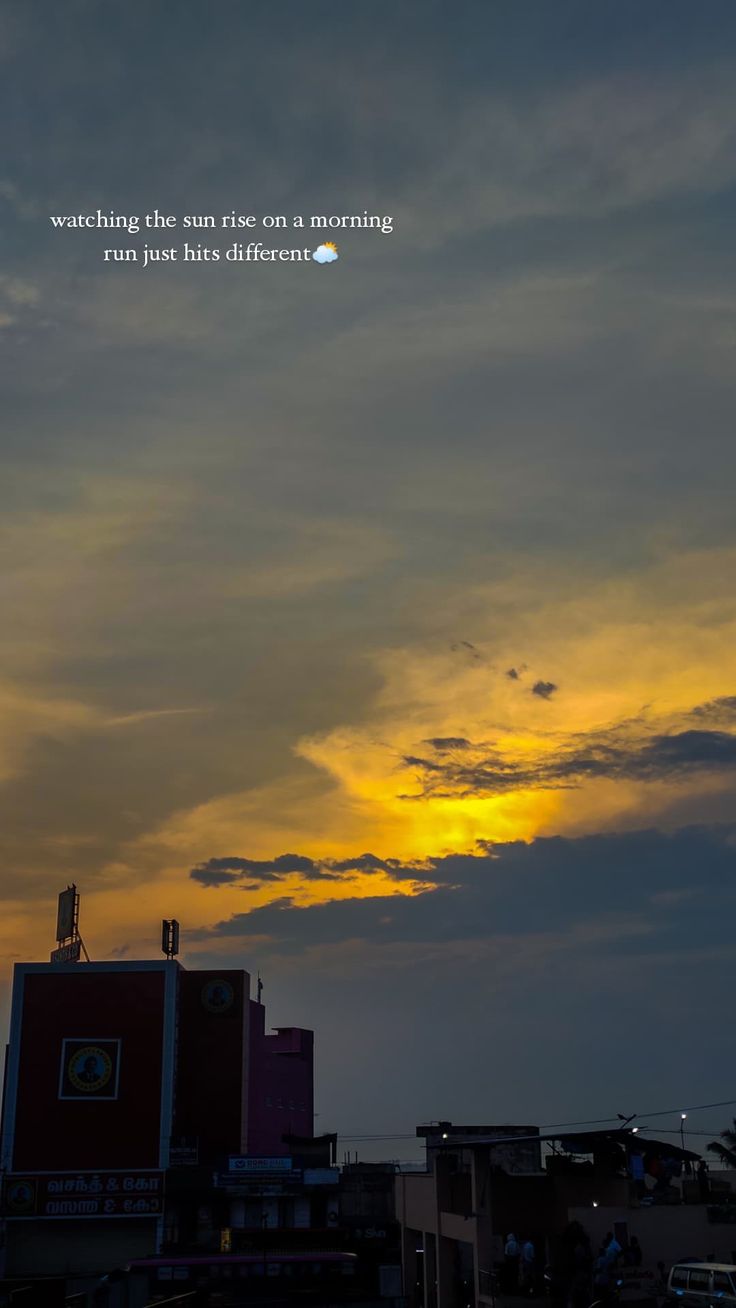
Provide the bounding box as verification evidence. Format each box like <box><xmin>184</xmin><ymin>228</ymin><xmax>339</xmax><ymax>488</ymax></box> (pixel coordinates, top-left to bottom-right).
<box><xmin>195</xmin><ymin>825</ymin><xmax>736</xmax><ymax>956</ymax></box>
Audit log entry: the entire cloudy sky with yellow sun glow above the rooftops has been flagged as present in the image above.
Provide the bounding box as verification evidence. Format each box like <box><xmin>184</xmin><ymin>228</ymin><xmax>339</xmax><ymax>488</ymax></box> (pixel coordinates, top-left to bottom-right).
<box><xmin>0</xmin><ymin>0</ymin><xmax>736</xmax><ymax>1156</ymax></box>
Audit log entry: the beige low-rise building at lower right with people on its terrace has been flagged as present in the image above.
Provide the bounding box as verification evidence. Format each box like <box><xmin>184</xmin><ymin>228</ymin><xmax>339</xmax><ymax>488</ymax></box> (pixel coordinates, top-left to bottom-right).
<box><xmin>396</xmin><ymin>1122</ymin><xmax>736</xmax><ymax>1308</ymax></box>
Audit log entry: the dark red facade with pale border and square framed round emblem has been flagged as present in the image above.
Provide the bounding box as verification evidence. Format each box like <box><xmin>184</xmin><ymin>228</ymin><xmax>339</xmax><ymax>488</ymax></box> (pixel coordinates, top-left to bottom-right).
<box><xmin>3</xmin><ymin>961</ymin><xmax>179</xmax><ymax>1173</ymax></box>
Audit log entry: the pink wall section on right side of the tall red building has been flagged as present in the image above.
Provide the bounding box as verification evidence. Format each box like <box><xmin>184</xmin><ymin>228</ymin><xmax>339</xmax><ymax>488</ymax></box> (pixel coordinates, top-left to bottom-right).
<box><xmin>248</xmin><ymin>999</ymin><xmax>314</xmax><ymax>1158</ymax></box>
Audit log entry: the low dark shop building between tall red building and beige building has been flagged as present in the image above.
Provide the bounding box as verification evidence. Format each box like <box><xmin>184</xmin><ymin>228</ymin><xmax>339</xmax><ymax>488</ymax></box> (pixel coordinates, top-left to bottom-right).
<box><xmin>123</xmin><ymin>1135</ymin><xmax>405</xmax><ymax>1308</ymax></box>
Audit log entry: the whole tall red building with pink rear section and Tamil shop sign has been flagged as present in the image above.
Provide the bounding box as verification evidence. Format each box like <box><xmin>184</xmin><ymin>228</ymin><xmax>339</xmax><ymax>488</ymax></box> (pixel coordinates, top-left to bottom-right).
<box><xmin>1</xmin><ymin>957</ymin><xmax>314</xmax><ymax>1278</ymax></box>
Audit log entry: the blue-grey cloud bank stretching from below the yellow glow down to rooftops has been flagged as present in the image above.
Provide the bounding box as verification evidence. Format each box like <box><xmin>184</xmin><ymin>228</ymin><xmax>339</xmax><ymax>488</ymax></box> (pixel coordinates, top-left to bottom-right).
<box><xmin>187</xmin><ymin>824</ymin><xmax>736</xmax><ymax>1156</ymax></box>
